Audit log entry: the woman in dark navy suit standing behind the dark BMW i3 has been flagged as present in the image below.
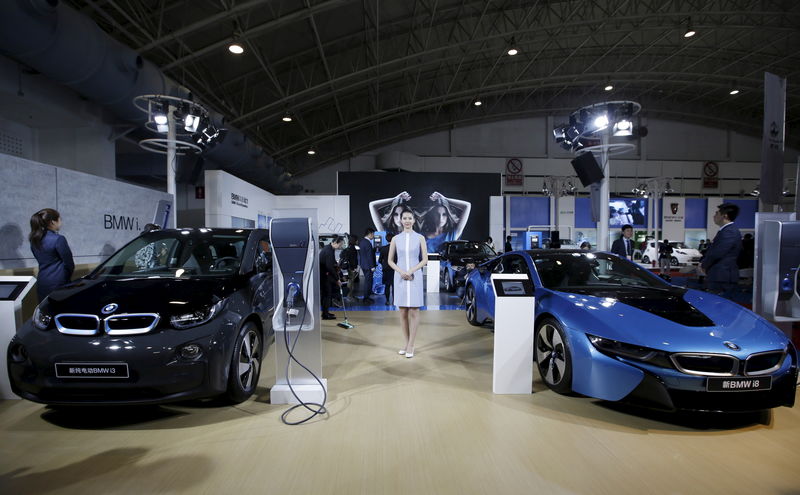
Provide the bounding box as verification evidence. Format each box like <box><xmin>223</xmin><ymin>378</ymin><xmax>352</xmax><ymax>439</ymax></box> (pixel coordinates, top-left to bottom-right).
<box><xmin>28</xmin><ymin>208</ymin><xmax>75</xmax><ymax>302</ymax></box>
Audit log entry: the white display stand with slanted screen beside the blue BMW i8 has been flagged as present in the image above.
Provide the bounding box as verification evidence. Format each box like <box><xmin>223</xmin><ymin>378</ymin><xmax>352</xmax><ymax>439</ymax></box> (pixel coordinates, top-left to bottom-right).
<box><xmin>492</xmin><ymin>273</ymin><xmax>536</xmax><ymax>394</ymax></box>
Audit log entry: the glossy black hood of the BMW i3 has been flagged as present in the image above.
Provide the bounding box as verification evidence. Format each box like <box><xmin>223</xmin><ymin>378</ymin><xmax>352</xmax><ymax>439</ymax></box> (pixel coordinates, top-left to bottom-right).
<box><xmin>47</xmin><ymin>278</ymin><xmax>234</xmax><ymax>317</ymax></box>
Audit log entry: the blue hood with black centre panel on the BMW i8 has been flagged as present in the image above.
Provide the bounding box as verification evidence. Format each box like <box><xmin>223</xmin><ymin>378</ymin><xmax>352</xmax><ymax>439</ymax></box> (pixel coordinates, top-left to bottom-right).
<box><xmin>553</xmin><ymin>288</ymin><xmax>788</xmax><ymax>357</ymax></box>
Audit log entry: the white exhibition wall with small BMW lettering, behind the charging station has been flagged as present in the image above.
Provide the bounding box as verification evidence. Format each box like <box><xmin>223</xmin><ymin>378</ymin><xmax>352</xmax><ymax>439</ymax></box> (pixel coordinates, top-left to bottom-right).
<box><xmin>205</xmin><ymin>170</ymin><xmax>350</xmax><ymax>234</ymax></box>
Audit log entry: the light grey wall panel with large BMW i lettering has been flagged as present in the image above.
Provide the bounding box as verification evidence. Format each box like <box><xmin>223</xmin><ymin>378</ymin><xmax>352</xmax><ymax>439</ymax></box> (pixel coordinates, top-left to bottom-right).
<box><xmin>0</xmin><ymin>154</ymin><xmax>172</xmax><ymax>269</ymax></box>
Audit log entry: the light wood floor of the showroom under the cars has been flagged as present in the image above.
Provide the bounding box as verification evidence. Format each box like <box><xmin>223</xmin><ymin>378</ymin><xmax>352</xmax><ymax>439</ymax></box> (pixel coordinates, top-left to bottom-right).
<box><xmin>0</xmin><ymin>311</ymin><xmax>800</xmax><ymax>495</ymax></box>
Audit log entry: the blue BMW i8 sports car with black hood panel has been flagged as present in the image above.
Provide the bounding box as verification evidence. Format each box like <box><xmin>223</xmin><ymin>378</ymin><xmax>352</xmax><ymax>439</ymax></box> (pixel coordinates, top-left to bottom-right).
<box><xmin>466</xmin><ymin>250</ymin><xmax>797</xmax><ymax>412</ymax></box>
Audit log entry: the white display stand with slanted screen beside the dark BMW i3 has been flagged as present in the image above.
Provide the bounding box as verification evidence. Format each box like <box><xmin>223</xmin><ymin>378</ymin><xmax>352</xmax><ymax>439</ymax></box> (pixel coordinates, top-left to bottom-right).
<box><xmin>0</xmin><ymin>276</ymin><xmax>36</xmax><ymax>399</ymax></box>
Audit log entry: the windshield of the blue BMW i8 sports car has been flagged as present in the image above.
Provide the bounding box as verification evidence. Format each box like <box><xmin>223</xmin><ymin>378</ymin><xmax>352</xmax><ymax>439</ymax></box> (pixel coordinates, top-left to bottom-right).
<box><xmin>533</xmin><ymin>253</ymin><xmax>669</xmax><ymax>291</ymax></box>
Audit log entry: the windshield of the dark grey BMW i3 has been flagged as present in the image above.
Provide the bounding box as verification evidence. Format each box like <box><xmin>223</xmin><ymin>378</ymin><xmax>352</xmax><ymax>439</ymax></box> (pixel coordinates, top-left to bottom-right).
<box><xmin>92</xmin><ymin>230</ymin><xmax>247</xmax><ymax>278</ymax></box>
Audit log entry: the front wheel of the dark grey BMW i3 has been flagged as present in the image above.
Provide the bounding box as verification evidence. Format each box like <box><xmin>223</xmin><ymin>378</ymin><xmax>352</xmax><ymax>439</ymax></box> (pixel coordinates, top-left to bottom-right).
<box><xmin>226</xmin><ymin>322</ymin><xmax>264</xmax><ymax>404</ymax></box>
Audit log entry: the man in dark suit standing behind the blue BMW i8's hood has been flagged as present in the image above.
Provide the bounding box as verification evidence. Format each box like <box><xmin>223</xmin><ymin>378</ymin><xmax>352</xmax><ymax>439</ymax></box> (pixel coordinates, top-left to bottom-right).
<box><xmin>700</xmin><ymin>203</ymin><xmax>742</xmax><ymax>294</ymax></box>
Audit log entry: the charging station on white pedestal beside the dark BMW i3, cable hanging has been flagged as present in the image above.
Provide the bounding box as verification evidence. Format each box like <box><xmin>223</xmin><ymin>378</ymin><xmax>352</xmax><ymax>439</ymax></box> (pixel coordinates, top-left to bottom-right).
<box><xmin>269</xmin><ymin>214</ymin><xmax>328</xmax><ymax>404</ymax></box>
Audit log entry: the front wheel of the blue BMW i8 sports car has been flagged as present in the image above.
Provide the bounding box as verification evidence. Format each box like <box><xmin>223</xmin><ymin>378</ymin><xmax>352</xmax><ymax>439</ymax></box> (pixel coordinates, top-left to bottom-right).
<box><xmin>533</xmin><ymin>318</ymin><xmax>572</xmax><ymax>394</ymax></box>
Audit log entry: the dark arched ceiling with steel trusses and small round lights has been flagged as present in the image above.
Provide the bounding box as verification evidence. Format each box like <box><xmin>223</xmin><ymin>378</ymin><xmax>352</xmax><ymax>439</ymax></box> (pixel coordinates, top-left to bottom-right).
<box><xmin>68</xmin><ymin>0</ymin><xmax>800</xmax><ymax>176</ymax></box>
